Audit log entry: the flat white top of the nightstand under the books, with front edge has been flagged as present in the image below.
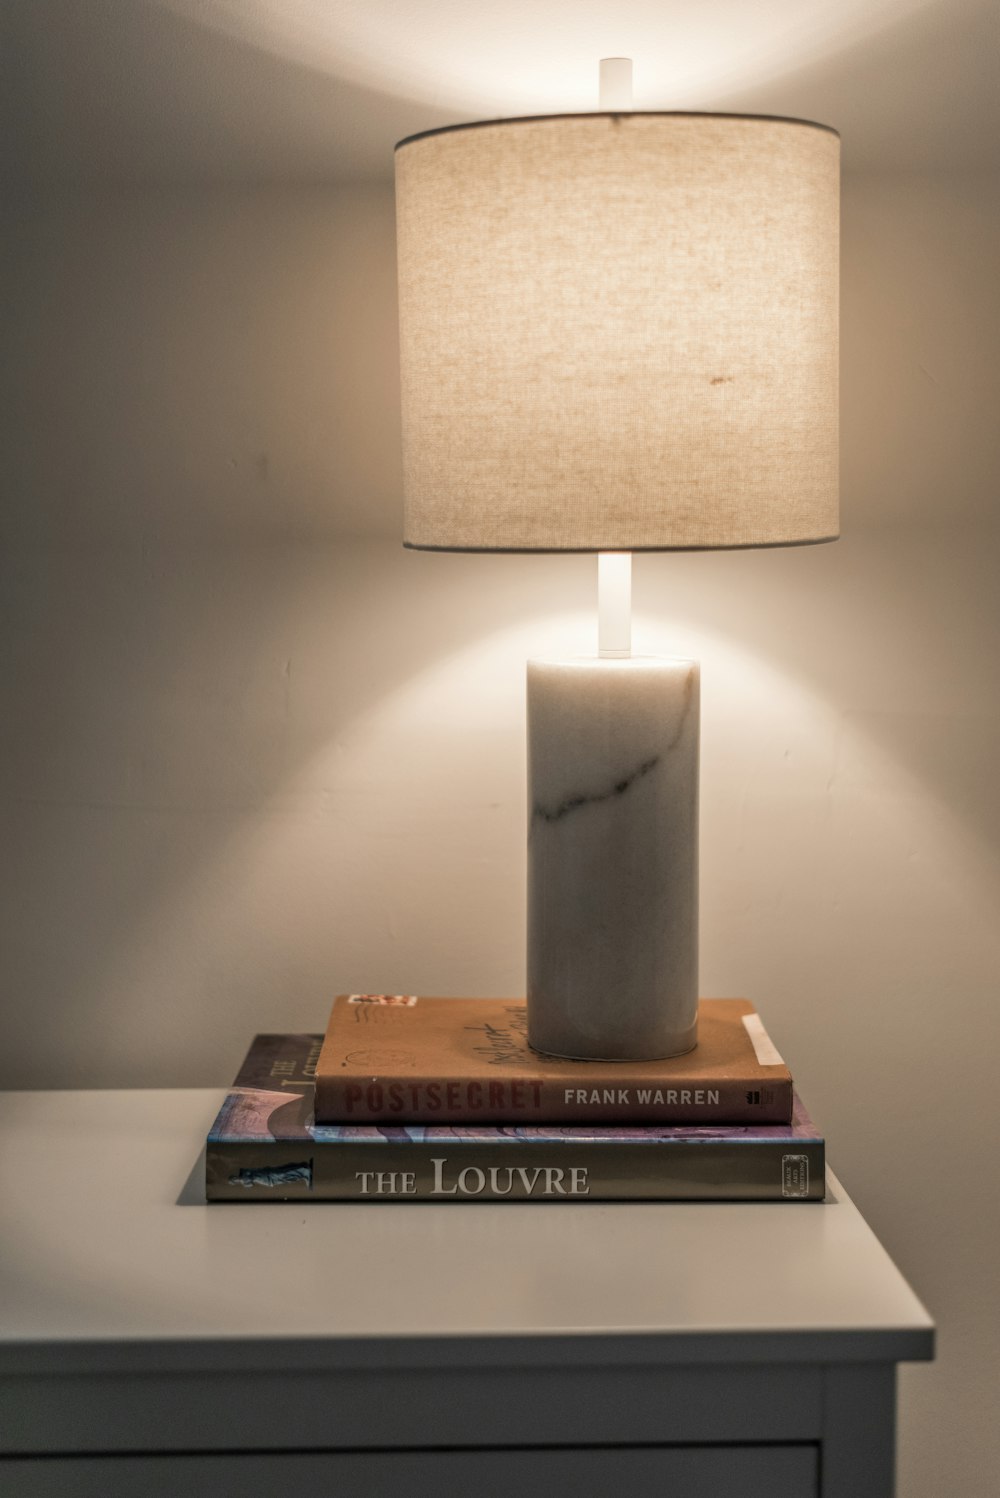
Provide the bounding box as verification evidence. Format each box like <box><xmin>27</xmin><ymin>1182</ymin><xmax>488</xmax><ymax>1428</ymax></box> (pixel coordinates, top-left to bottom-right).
<box><xmin>0</xmin><ymin>1091</ymin><xmax>933</xmax><ymax>1372</ymax></box>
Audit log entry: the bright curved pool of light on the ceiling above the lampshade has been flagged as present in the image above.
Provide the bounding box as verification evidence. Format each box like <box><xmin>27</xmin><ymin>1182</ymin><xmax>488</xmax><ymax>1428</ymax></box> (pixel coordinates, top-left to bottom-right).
<box><xmin>150</xmin><ymin>0</ymin><xmax>931</xmax><ymax>117</ymax></box>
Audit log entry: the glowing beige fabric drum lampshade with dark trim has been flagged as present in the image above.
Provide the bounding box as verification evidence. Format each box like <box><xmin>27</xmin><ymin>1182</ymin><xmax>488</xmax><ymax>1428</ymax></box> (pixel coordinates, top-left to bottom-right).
<box><xmin>397</xmin><ymin>114</ymin><xmax>840</xmax><ymax>551</ymax></box>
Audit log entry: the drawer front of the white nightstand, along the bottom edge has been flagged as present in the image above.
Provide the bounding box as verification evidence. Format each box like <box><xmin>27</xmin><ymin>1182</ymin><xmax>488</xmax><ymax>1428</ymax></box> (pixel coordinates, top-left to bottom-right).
<box><xmin>0</xmin><ymin>1446</ymin><xmax>819</xmax><ymax>1498</ymax></box>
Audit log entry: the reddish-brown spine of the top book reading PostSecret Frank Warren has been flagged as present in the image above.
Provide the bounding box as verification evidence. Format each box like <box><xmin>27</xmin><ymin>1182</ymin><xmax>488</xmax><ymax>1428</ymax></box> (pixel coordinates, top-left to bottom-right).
<box><xmin>314</xmin><ymin>1076</ymin><xmax>792</xmax><ymax>1126</ymax></box>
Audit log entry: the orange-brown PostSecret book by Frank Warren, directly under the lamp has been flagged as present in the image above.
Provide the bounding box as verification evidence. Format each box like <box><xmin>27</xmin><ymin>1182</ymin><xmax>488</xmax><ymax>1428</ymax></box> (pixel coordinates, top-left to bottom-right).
<box><xmin>316</xmin><ymin>993</ymin><xmax>792</xmax><ymax>1125</ymax></box>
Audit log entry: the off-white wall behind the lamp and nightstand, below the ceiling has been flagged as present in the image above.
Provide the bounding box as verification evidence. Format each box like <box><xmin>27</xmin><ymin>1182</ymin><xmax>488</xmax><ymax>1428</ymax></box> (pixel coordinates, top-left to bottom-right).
<box><xmin>0</xmin><ymin>175</ymin><xmax>1000</xmax><ymax>1498</ymax></box>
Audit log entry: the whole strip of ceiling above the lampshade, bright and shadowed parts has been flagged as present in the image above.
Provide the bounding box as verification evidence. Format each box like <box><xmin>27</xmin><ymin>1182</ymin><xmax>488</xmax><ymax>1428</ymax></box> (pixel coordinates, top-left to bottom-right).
<box><xmin>0</xmin><ymin>0</ymin><xmax>1000</xmax><ymax>187</ymax></box>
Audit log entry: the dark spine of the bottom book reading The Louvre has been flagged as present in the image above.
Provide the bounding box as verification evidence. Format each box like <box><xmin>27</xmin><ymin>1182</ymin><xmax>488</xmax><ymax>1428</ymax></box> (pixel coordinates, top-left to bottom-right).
<box><xmin>205</xmin><ymin>1138</ymin><xmax>825</xmax><ymax>1203</ymax></box>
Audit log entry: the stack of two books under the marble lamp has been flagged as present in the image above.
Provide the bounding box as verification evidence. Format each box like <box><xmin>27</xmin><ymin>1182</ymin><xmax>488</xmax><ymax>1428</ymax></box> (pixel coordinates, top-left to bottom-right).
<box><xmin>205</xmin><ymin>993</ymin><xmax>825</xmax><ymax>1201</ymax></box>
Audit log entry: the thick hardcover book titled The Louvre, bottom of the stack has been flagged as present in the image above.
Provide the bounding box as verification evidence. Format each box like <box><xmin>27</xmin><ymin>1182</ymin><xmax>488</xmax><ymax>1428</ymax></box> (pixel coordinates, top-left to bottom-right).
<box><xmin>205</xmin><ymin>1035</ymin><xmax>825</xmax><ymax>1203</ymax></box>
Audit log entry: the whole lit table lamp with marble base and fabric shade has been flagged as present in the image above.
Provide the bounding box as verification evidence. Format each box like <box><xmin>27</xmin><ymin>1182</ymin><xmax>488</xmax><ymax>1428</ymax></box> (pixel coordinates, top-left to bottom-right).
<box><xmin>395</xmin><ymin>58</ymin><xmax>840</xmax><ymax>1061</ymax></box>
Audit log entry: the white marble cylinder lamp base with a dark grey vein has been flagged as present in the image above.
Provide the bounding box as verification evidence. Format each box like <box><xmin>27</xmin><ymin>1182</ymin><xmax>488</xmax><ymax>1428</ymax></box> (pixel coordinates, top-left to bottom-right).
<box><xmin>527</xmin><ymin>656</ymin><xmax>699</xmax><ymax>1061</ymax></box>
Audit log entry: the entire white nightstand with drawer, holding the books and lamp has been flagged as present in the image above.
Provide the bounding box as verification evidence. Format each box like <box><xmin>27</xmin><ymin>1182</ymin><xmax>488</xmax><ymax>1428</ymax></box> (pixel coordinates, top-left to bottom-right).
<box><xmin>0</xmin><ymin>1091</ymin><xmax>933</xmax><ymax>1498</ymax></box>
